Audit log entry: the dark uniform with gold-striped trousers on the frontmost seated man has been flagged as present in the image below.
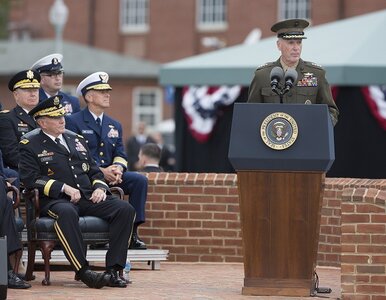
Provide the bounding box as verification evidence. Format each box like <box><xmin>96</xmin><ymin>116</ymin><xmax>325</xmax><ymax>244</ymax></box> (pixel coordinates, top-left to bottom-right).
<box><xmin>19</xmin><ymin>128</ymin><xmax>135</xmax><ymax>271</ymax></box>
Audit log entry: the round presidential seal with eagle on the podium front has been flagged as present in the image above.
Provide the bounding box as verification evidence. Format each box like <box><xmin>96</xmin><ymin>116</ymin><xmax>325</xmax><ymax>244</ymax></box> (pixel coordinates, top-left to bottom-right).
<box><xmin>260</xmin><ymin>112</ymin><xmax>298</xmax><ymax>150</ymax></box>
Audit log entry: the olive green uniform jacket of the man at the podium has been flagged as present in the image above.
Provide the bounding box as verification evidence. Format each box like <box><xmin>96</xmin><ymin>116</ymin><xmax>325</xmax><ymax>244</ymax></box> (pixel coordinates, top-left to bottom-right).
<box><xmin>248</xmin><ymin>59</ymin><xmax>339</xmax><ymax>125</ymax></box>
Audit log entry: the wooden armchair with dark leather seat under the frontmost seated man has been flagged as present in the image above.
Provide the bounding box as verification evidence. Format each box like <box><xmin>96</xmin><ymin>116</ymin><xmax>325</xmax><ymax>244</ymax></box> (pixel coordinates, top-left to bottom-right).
<box><xmin>22</xmin><ymin>187</ymin><xmax>124</xmax><ymax>285</ymax></box>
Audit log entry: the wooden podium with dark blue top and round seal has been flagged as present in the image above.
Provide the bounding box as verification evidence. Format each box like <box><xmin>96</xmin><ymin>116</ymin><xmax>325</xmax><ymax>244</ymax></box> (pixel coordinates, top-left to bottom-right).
<box><xmin>229</xmin><ymin>103</ymin><xmax>335</xmax><ymax>296</ymax></box>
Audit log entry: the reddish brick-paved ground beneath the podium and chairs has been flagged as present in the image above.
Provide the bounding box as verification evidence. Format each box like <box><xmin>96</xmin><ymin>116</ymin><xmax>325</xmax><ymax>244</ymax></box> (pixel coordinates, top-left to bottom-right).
<box><xmin>8</xmin><ymin>262</ymin><xmax>340</xmax><ymax>300</ymax></box>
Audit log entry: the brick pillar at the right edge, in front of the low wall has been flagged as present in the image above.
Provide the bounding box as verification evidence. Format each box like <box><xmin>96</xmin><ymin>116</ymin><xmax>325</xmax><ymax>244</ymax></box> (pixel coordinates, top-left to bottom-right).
<box><xmin>341</xmin><ymin>187</ymin><xmax>386</xmax><ymax>300</ymax></box>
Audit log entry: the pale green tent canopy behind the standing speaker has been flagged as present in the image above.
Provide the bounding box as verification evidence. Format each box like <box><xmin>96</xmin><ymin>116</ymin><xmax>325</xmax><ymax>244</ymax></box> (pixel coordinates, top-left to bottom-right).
<box><xmin>160</xmin><ymin>10</ymin><xmax>386</xmax><ymax>86</ymax></box>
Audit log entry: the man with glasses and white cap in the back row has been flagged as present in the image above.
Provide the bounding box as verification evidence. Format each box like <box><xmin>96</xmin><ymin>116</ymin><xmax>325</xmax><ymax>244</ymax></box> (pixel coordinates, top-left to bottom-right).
<box><xmin>31</xmin><ymin>53</ymin><xmax>80</xmax><ymax>115</ymax></box>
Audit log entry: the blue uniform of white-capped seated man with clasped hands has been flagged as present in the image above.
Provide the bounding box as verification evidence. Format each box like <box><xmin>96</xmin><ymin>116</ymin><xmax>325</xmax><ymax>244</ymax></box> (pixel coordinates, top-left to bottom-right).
<box><xmin>66</xmin><ymin>107</ymin><xmax>147</xmax><ymax>224</ymax></box>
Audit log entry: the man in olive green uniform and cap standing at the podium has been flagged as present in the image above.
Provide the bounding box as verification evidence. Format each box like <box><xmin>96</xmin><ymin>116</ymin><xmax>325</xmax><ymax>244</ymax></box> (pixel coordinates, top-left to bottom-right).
<box><xmin>248</xmin><ymin>19</ymin><xmax>339</xmax><ymax>125</ymax></box>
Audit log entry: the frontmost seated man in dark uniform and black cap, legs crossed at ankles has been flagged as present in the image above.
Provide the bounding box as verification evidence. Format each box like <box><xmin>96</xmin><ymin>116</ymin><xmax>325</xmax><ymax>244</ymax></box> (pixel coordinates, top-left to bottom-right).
<box><xmin>19</xmin><ymin>95</ymin><xmax>135</xmax><ymax>288</ymax></box>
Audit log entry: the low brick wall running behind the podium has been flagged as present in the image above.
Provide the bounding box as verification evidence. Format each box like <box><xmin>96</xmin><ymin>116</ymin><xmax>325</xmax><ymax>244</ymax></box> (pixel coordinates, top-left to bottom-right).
<box><xmin>140</xmin><ymin>173</ymin><xmax>386</xmax><ymax>267</ymax></box>
